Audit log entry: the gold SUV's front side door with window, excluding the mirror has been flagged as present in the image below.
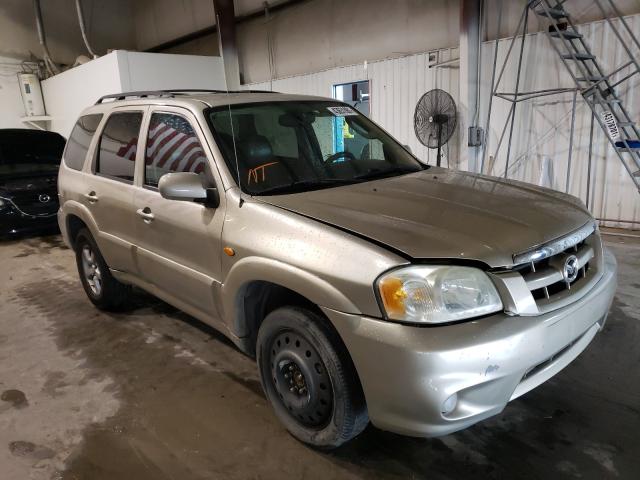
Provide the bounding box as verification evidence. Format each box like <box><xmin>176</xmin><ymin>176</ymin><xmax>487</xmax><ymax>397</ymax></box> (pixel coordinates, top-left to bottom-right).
<box><xmin>134</xmin><ymin>107</ymin><xmax>224</xmax><ymax>323</ymax></box>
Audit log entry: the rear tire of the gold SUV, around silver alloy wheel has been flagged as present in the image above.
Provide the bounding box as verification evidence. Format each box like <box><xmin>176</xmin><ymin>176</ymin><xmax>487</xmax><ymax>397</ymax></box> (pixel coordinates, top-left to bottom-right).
<box><xmin>74</xmin><ymin>228</ymin><xmax>131</xmax><ymax>311</ymax></box>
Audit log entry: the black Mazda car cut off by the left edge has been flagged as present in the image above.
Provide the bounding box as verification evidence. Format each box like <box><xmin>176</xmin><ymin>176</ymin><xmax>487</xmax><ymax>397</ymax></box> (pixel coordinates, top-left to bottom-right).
<box><xmin>0</xmin><ymin>128</ymin><xmax>65</xmax><ymax>238</ymax></box>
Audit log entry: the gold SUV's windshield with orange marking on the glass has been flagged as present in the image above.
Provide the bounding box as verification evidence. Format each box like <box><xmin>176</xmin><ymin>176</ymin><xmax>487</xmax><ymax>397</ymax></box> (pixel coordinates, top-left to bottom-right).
<box><xmin>208</xmin><ymin>101</ymin><xmax>427</xmax><ymax>195</ymax></box>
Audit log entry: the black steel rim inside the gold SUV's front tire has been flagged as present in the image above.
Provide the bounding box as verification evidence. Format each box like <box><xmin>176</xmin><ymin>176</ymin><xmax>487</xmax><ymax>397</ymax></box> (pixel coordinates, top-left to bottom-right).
<box><xmin>269</xmin><ymin>330</ymin><xmax>333</xmax><ymax>429</ymax></box>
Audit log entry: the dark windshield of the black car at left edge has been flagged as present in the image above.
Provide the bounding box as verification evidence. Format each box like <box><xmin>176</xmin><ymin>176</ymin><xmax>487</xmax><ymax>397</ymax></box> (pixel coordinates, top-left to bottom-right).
<box><xmin>0</xmin><ymin>130</ymin><xmax>65</xmax><ymax>177</ymax></box>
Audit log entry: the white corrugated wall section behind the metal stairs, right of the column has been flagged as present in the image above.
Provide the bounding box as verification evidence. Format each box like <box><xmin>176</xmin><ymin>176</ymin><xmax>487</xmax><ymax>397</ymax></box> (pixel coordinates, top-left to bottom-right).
<box><xmin>481</xmin><ymin>15</ymin><xmax>640</xmax><ymax>227</ymax></box>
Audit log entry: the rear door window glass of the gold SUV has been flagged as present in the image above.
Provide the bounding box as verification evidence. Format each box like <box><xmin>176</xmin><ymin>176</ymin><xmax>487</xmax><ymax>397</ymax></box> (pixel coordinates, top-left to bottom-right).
<box><xmin>95</xmin><ymin>112</ymin><xmax>142</xmax><ymax>182</ymax></box>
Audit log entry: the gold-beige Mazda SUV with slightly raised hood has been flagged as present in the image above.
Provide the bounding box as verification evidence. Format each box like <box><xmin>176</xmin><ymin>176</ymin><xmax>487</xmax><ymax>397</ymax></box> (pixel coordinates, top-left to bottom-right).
<box><xmin>59</xmin><ymin>91</ymin><xmax>616</xmax><ymax>448</ymax></box>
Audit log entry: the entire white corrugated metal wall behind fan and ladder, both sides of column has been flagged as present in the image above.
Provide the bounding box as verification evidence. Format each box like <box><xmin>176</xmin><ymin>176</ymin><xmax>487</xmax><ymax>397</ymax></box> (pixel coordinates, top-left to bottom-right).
<box><xmin>247</xmin><ymin>15</ymin><xmax>640</xmax><ymax>227</ymax></box>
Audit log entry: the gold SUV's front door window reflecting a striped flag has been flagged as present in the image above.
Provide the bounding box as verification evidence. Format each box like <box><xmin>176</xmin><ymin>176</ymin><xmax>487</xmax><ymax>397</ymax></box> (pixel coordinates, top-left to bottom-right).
<box><xmin>144</xmin><ymin>113</ymin><xmax>207</xmax><ymax>187</ymax></box>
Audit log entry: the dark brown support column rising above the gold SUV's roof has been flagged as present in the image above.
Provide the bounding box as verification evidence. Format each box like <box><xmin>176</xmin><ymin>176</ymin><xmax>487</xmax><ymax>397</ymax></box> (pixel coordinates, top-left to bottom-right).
<box><xmin>213</xmin><ymin>0</ymin><xmax>240</xmax><ymax>90</ymax></box>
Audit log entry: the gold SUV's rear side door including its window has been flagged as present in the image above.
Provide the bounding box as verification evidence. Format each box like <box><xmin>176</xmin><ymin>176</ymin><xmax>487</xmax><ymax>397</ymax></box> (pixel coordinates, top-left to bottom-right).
<box><xmin>82</xmin><ymin>107</ymin><xmax>147</xmax><ymax>272</ymax></box>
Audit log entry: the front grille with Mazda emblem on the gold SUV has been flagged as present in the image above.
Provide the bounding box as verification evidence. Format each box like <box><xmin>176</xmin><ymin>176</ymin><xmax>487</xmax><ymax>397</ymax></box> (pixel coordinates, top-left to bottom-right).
<box><xmin>515</xmin><ymin>228</ymin><xmax>602</xmax><ymax>312</ymax></box>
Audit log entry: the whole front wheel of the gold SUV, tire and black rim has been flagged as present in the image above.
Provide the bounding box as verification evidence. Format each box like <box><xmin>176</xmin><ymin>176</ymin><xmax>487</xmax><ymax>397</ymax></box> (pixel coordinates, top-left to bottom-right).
<box><xmin>256</xmin><ymin>307</ymin><xmax>369</xmax><ymax>449</ymax></box>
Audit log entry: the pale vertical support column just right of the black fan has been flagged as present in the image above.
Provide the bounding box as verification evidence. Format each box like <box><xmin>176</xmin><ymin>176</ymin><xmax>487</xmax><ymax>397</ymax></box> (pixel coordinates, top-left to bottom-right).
<box><xmin>459</xmin><ymin>0</ymin><xmax>482</xmax><ymax>172</ymax></box>
